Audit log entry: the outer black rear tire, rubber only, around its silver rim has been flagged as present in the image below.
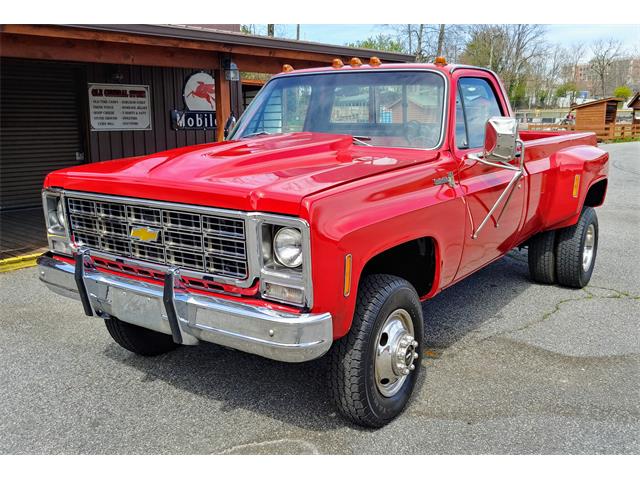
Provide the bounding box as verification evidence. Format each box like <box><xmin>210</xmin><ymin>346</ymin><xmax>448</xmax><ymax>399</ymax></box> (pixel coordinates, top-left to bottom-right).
<box><xmin>556</xmin><ymin>207</ymin><xmax>598</xmax><ymax>288</ymax></box>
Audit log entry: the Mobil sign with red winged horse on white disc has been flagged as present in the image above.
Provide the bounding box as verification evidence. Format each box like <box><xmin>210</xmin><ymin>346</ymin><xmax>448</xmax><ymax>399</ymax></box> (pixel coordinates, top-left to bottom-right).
<box><xmin>170</xmin><ymin>72</ymin><xmax>216</xmax><ymax>130</ymax></box>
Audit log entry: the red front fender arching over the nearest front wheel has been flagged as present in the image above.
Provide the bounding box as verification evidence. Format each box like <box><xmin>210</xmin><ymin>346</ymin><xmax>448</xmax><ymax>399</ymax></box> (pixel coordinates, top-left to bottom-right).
<box><xmin>303</xmin><ymin>163</ymin><xmax>465</xmax><ymax>339</ymax></box>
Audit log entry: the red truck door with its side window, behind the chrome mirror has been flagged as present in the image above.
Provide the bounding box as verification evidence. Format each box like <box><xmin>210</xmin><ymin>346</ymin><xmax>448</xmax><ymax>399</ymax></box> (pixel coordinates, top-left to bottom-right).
<box><xmin>452</xmin><ymin>70</ymin><xmax>525</xmax><ymax>279</ymax></box>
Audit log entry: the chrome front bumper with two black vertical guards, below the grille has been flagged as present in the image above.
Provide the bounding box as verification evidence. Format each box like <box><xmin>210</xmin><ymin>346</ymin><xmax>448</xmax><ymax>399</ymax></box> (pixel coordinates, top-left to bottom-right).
<box><xmin>38</xmin><ymin>251</ymin><xmax>333</xmax><ymax>362</ymax></box>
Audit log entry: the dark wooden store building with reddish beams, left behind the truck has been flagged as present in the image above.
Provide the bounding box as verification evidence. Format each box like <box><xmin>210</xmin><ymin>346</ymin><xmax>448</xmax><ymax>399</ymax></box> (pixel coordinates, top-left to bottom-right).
<box><xmin>0</xmin><ymin>25</ymin><xmax>413</xmax><ymax>212</ymax></box>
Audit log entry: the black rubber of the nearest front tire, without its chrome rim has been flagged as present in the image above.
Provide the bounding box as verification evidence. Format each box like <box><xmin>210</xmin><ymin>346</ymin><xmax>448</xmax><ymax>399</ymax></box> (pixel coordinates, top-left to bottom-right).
<box><xmin>329</xmin><ymin>275</ymin><xmax>424</xmax><ymax>428</ymax></box>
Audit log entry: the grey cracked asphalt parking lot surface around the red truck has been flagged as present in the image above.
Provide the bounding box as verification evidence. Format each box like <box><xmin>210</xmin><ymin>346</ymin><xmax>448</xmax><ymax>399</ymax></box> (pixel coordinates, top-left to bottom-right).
<box><xmin>0</xmin><ymin>143</ymin><xmax>640</xmax><ymax>454</ymax></box>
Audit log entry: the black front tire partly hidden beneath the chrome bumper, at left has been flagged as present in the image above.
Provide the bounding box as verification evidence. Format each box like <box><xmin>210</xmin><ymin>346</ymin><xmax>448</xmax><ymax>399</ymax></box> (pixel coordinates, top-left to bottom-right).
<box><xmin>104</xmin><ymin>317</ymin><xmax>178</xmax><ymax>357</ymax></box>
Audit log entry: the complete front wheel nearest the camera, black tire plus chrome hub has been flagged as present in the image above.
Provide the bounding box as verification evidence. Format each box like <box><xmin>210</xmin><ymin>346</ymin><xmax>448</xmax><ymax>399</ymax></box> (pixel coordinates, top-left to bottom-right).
<box><xmin>329</xmin><ymin>275</ymin><xmax>424</xmax><ymax>428</ymax></box>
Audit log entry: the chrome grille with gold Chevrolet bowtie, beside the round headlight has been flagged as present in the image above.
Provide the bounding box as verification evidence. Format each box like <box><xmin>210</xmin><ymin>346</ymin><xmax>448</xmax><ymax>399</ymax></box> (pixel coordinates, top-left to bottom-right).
<box><xmin>67</xmin><ymin>196</ymin><xmax>249</xmax><ymax>280</ymax></box>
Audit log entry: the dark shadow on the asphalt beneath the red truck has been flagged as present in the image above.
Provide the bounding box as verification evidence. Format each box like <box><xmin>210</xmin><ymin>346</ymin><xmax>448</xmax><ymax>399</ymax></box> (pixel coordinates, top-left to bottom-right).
<box><xmin>105</xmin><ymin>248</ymin><xmax>529</xmax><ymax>431</ymax></box>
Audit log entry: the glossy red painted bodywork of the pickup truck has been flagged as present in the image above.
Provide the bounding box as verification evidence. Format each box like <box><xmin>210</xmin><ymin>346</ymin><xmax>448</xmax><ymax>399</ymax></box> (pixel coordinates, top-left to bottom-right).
<box><xmin>45</xmin><ymin>64</ymin><xmax>608</xmax><ymax>338</ymax></box>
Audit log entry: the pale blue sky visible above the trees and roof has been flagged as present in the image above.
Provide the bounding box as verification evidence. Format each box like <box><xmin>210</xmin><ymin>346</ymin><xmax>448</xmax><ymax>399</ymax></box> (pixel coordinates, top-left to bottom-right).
<box><xmin>270</xmin><ymin>24</ymin><xmax>640</xmax><ymax>53</ymax></box>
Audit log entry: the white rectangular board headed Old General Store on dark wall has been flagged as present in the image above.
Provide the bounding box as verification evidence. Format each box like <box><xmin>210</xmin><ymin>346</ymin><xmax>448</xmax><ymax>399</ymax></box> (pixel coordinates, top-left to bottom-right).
<box><xmin>89</xmin><ymin>83</ymin><xmax>151</xmax><ymax>131</ymax></box>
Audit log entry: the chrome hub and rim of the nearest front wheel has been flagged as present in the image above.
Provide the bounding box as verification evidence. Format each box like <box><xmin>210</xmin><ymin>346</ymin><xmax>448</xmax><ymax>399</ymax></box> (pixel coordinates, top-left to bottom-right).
<box><xmin>375</xmin><ymin>308</ymin><xmax>418</xmax><ymax>397</ymax></box>
